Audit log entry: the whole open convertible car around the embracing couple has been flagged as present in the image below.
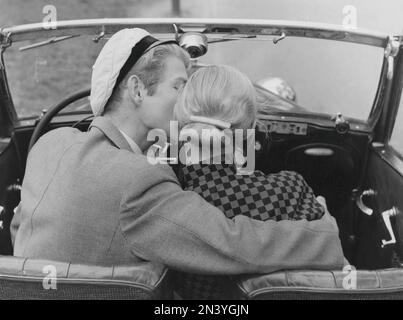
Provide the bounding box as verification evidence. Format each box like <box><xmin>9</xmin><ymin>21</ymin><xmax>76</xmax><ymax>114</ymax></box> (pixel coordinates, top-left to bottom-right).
<box><xmin>0</xmin><ymin>18</ymin><xmax>403</xmax><ymax>299</ymax></box>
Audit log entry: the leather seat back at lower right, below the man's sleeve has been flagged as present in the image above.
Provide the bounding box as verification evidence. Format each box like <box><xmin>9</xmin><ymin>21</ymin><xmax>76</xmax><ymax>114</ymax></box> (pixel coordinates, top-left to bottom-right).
<box><xmin>237</xmin><ymin>268</ymin><xmax>403</xmax><ymax>300</ymax></box>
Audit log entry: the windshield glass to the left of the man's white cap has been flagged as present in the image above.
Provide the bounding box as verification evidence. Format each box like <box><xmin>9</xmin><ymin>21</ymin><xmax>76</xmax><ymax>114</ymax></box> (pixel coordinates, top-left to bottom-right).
<box><xmin>4</xmin><ymin>36</ymin><xmax>104</xmax><ymax>118</ymax></box>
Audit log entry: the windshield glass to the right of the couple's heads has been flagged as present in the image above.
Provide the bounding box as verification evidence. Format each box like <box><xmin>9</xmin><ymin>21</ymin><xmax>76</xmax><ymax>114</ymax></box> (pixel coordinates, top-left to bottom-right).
<box><xmin>201</xmin><ymin>38</ymin><xmax>383</xmax><ymax>120</ymax></box>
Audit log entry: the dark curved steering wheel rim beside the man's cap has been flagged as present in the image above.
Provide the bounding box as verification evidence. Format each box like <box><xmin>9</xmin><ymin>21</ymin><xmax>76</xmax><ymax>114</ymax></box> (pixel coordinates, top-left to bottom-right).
<box><xmin>28</xmin><ymin>89</ymin><xmax>91</xmax><ymax>152</ymax></box>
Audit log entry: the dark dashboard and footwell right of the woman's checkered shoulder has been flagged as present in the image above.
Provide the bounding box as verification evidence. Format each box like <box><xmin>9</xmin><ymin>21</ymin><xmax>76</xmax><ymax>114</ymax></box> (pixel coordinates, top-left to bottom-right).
<box><xmin>256</xmin><ymin>123</ymin><xmax>372</xmax><ymax>263</ymax></box>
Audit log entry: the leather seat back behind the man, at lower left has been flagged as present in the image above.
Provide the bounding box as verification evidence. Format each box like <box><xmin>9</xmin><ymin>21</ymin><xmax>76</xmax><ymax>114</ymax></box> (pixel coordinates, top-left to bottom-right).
<box><xmin>0</xmin><ymin>256</ymin><xmax>172</xmax><ymax>300</ymax></box>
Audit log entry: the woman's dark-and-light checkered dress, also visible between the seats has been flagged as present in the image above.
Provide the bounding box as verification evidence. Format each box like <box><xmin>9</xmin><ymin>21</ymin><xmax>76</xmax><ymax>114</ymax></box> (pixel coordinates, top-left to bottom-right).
<box><xmin>176</xmin><ymin>164</ymin><xmax>324</xmax><ymax>299</ymax></box>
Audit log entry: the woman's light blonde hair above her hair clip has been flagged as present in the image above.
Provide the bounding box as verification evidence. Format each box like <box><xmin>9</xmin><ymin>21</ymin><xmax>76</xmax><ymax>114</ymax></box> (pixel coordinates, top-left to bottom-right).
<box><xmin>174</xmin><ymin>65</ymin><xmax>256</xmax><ymax>129</ymax></box>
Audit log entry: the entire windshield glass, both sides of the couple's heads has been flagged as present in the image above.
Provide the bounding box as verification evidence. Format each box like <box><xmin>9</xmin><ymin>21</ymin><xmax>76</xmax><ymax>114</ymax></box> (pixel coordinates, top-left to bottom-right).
<box><xmin>5</xmin><ymin>32</ymin><xmax>383</xmax><ymax>120</ymax></box>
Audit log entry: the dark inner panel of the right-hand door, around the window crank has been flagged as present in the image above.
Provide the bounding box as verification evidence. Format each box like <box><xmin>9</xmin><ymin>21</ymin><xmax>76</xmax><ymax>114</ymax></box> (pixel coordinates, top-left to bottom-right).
<box><xmin>356</xmin><ymin>147</ymin><xmax>403</xmax><ymax>269</ymax></box>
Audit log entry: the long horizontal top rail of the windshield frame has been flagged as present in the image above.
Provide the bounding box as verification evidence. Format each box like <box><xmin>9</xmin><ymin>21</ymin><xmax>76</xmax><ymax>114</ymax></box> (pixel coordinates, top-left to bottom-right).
<box><xmin>0</xmin><ymin>18</ymin><xmax>388</xmax><ymax>48</ymax></box>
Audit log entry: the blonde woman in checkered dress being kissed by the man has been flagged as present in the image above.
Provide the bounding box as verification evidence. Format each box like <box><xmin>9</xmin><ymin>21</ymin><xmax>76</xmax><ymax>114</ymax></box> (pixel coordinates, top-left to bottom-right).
<box><xmin>174</xmin><ymin>66</ymin><xmax>325</xmax><ymax>299</ymax></box>
